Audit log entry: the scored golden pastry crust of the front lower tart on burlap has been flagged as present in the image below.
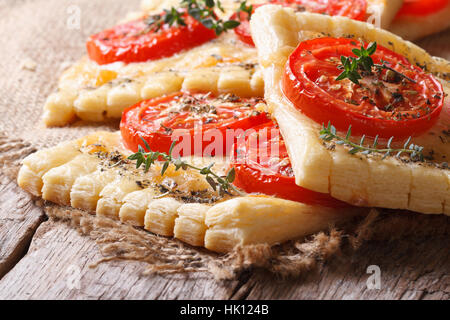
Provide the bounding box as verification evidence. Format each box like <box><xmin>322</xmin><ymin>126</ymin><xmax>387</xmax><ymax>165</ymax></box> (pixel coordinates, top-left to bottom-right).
<box><xmin>18</xmin><ymin>132</ymin><xmax>359</xmax><ymax>252</ymax></box>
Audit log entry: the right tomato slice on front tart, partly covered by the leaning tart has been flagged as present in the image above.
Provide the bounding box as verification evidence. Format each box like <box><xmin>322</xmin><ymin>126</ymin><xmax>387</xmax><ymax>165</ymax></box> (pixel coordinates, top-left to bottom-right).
<box><xmin>232</xmin><ymin>121</ymin><xmax>349</xmax><ymax>208</ymax></box>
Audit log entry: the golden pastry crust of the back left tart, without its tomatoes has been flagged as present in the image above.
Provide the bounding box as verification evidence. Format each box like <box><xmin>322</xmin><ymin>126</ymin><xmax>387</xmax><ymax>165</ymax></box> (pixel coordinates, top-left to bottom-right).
<box><xmin>43</xmin><ymin>0</ymin><xmax>264</xmax><ymax>127</ymax></box>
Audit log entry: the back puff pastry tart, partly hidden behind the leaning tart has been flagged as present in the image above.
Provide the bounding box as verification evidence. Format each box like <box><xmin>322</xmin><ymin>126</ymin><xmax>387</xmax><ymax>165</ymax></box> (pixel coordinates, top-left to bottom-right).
<box><xmin>43</xmin><ymin>0</ymin><xmax>400</xmax><ymax>126</ymax></box>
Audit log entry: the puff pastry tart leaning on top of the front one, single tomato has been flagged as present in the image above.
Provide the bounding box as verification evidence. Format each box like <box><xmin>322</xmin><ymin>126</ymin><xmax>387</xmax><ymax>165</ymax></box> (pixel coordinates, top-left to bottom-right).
<box><xmin>251</xmin><ymin>5</ymin><xmax>450</xmax><ymax>215</ymax></box>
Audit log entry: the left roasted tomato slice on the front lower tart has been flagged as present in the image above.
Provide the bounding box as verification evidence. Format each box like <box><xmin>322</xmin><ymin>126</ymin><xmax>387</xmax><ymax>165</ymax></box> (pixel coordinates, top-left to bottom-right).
<box><xmin>120</xmin><ymin>92</ymin><xmax>269</xmax><ymax>156</ymax></box>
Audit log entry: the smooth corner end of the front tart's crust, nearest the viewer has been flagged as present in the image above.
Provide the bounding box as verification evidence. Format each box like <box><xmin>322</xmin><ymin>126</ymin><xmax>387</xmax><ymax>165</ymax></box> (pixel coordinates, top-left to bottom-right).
<box><xmin>205</xmin><ymin>196</ymin><xmax>350</xmax><ymax>252</ymax></box>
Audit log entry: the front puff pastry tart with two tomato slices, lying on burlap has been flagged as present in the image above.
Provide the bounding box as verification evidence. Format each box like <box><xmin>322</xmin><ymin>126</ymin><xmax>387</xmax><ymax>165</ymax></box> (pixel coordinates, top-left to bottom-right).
<box><xmin>18</xmin><ymin>92</ymin><xmax>361</xmax><ymax>252</ymax></box>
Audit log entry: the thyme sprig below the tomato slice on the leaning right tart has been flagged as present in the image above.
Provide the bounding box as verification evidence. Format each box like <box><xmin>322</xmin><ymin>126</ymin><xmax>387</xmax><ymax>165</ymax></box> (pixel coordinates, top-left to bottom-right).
<box><xmin>320</xmin><ymin>122</ymin><xmax>424</xmax><ymax>161</ymax></box>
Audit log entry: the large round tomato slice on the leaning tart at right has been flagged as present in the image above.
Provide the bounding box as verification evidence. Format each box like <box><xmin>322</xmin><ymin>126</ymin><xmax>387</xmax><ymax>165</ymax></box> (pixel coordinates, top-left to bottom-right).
<box><xmin>282</xmin><ymin>38</ymin><xmax>444</xmax><ymax>138</ymax></box>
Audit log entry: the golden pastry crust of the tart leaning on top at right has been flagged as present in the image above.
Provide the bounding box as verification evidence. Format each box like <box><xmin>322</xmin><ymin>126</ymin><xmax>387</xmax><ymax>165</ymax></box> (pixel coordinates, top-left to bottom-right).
<box><xmin>251</xmin><ymin>6</ymin><xmax>450</xmax><ymax>214</ymax></box>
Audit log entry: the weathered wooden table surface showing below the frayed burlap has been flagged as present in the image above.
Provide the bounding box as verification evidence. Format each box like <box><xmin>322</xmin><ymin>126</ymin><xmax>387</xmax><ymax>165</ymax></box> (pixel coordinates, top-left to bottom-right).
<box><xmin>0</xmin><ymin>1</ymin><xmax>450</xmax><ymax>299</ymax></box>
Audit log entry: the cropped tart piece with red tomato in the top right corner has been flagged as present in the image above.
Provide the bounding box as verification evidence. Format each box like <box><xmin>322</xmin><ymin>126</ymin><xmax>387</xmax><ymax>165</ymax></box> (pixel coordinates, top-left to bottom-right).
<box><xmin>389</xmin><ymin>0</ymin><xmax>450</xmax><ymax>40</ymax></box>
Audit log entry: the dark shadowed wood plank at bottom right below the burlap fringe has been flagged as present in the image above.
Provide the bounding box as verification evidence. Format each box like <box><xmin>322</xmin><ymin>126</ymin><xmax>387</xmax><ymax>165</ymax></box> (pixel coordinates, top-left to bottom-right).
<box><xmin>233</xmin><ymin>236</ymin><xmax>450</xmax><ymax>300</ymax></box>
